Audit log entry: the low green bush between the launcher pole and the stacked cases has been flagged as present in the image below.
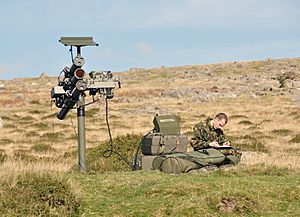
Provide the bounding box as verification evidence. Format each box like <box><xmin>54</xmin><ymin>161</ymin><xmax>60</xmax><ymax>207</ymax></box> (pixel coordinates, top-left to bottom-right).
<box><xmin>87</xmin><ymin>134</ymin><xmax>142</xmax><ymax>173</ymax></box>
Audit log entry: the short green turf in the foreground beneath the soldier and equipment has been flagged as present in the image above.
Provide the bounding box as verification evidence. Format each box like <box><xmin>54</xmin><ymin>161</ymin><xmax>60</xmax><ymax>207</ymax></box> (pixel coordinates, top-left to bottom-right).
<box><xmin>72</xmin><ymin>166</ymin><xmax>300</xmax><ymax>216</ymax></box>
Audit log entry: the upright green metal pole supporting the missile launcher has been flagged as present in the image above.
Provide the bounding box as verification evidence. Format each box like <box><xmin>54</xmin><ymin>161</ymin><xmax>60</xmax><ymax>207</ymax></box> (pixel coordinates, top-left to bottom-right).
<box><xmin>77</xmin><ymin>96</ymin><xmax>86</xmax><ymax>172</ymax></box>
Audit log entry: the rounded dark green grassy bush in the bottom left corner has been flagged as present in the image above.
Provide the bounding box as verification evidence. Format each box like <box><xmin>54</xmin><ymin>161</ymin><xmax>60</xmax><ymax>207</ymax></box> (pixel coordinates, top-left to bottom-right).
<box><xmin>0</xmin><ymin>173</ymin><xmax>80</xmax><ymax>216</ymax></box>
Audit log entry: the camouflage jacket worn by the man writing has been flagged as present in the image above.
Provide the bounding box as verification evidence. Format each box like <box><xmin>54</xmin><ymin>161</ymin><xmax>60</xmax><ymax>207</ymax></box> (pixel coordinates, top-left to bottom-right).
<box><xmin>191</xmin><ymin>118</ymin><xmax>227</xmax><ymax>150</ymax></box>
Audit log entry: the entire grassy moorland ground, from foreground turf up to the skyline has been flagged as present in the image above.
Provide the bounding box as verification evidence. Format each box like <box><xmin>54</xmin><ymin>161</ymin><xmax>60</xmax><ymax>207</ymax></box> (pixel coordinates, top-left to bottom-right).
<box><xmin>0</xmin><ymin>59</ymin><xmax>300</xmax><ymax>216</ymax></box>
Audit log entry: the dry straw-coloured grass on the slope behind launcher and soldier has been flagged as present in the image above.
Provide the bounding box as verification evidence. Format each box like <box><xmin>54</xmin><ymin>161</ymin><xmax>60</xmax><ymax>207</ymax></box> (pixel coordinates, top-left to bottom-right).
<box><xmin>0</xmin><ymin>59</ymin><xmax>300</xmax><ymax>172</ymax></box>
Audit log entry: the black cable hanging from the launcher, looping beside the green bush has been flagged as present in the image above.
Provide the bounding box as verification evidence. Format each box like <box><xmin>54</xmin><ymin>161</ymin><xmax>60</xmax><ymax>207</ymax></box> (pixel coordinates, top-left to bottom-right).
<box><xmin>102</xmin><ymin>97</ymin><xmax>135</xmax><ymax>170</ymax></box>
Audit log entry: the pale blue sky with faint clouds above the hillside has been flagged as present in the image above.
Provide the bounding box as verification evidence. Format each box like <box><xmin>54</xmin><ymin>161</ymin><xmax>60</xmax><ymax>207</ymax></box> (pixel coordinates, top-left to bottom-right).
<box><xmin>0</xmin><ymin>0</ymin><xmax>300</xmax><ymax>80</ymax></box>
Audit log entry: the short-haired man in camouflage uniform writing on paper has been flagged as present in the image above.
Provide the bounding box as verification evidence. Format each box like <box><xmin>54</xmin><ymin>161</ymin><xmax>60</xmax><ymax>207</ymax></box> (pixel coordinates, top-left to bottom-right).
<box><xmin>191</xmin><ymin>113</ymin><xmax>230</xmax><ymax>150</ymax></box>
